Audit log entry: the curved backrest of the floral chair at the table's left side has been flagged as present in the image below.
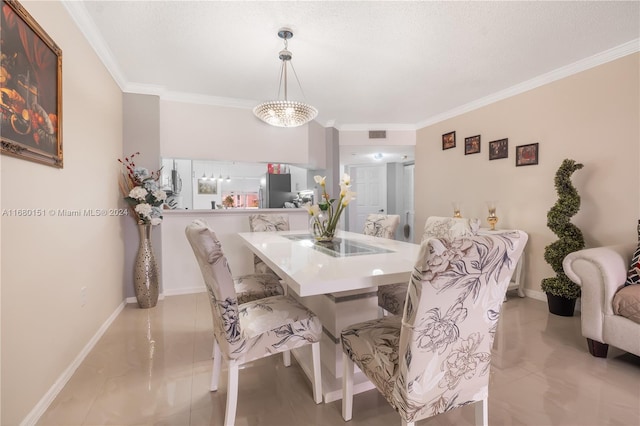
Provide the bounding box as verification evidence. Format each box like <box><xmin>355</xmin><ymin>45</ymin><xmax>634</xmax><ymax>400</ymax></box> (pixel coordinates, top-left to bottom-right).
<box><xmin>185</xmin><ymin>220</ymin><xmax>244</xmax><ymax>358</ymax></box>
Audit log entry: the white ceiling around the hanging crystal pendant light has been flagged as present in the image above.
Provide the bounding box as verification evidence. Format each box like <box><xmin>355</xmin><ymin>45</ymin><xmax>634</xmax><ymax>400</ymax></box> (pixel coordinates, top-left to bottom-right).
<box><xmin>65</xmin><ymin>1</ymin><xmax>640</xmax><ymax>129</ymax></box>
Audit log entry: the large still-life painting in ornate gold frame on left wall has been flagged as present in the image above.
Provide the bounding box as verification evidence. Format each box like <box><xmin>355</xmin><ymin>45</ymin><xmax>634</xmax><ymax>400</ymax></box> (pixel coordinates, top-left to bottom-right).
<box><xmin>0</xmin><ymin>0</ymin><xmax>63</xmax><ymax>168</ymax></box>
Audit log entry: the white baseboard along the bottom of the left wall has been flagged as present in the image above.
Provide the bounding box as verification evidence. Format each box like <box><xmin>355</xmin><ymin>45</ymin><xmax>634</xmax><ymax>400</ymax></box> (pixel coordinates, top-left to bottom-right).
<box><xmin>20</xmin><ymin>302</ymin><xmax>125</xmax><ymax>426</ymax></box>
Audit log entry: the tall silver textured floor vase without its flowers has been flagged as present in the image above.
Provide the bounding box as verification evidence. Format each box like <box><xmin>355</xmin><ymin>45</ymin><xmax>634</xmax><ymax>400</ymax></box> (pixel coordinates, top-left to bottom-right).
<box><xmin>133</xmin><ymin>225</ymin><xmax>158</xmax><ymax>309</ymax></box>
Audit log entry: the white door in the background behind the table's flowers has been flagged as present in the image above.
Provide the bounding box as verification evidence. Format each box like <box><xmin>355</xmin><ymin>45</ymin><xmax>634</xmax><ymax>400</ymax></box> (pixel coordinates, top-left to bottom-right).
<box><xmin>348</xmin><ymin>164</ymin><xmax>387</xmax><ymax>232</ymax></box>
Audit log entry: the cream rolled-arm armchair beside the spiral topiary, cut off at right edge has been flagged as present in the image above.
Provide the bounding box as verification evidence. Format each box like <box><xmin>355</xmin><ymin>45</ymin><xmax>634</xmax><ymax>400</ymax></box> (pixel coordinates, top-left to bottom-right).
<box><xmin>563</xmin><ymin>244</ymin><xmax>640</xmax><ymax>358</ymax></box>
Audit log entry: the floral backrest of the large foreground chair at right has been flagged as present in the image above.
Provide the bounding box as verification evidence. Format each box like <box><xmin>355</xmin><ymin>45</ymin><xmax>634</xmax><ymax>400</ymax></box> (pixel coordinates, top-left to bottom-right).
<box><xmin>393</xmin><ymin>231</ymin><xmax>527</xmax><ymax>421</ymax></box>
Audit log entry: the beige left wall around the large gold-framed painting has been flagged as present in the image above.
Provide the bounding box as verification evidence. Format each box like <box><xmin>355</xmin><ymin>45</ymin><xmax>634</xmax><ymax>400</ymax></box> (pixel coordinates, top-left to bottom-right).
<box><xmin>0</xmin><ymin>1</ymin><xmax>128</xmax><ymax>426</ymax></box>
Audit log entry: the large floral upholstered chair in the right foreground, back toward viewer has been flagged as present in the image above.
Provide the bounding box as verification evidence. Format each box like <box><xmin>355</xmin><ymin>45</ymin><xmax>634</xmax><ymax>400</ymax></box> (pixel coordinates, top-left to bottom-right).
<box><xmin>341</xmin><ymin>231</ymin><xmax>527</xmax><ymax>425</ymax></box>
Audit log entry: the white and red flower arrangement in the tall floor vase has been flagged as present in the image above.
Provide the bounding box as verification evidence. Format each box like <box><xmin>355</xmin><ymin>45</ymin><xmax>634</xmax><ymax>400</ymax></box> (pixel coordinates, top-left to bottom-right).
<box><xmin>118</xmin><ymin>152</ymin><xmax>167</xmax><ymax>225</ymax></box>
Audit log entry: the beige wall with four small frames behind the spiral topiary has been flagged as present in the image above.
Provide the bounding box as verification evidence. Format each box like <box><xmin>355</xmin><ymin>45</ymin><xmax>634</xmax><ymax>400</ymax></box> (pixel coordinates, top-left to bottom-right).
<box><xmin>415</xmin><ymin>54</ymin><xmax>640</xmax><ymax>297</ymax></box>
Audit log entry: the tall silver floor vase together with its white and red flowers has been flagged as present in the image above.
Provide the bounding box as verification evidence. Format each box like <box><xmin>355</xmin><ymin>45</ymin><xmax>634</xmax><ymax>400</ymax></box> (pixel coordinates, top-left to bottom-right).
<box><xmin>118</xmin><ymin>152</ymin><xmax>167</xmax><ymax>309</ymax></box>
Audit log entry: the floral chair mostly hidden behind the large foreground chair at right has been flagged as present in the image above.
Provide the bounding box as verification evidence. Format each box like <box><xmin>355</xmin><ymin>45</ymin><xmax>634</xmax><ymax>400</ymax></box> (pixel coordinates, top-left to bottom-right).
<box><xmin>378</xmin><ymin>216</ymin><xmax>480</xmax><ymax>315</ymax></box>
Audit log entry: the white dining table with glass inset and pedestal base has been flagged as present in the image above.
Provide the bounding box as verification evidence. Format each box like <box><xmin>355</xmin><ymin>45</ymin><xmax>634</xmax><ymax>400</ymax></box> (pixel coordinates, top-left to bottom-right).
<box><xmin>238</xmin><ymin>230</ymin><xmax>420</xmax><ymax>402</ymax></box>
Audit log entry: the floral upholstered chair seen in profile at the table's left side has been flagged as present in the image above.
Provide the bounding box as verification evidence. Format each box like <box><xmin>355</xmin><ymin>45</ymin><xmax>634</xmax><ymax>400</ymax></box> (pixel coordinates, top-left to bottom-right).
<box><xmin>185</xmin><ymin>220</ymin><xmax>322</xmax><ymax>425</ymax></box>
